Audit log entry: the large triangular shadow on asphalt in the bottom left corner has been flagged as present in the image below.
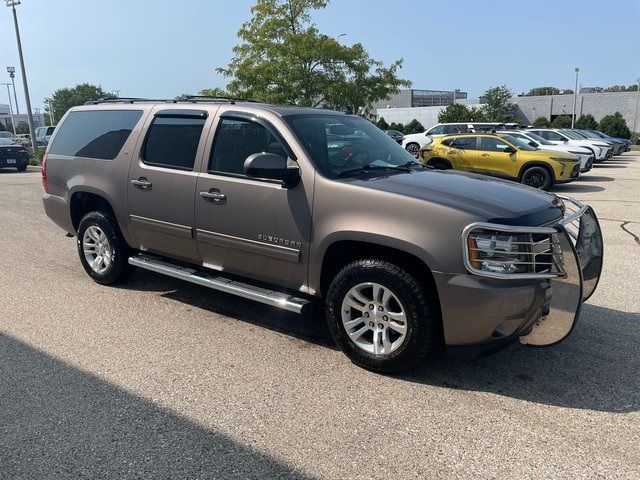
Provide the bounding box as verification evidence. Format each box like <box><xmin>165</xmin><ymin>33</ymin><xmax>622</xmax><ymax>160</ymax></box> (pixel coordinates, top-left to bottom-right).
<box><xmin>0</xmin><ymin>334</ymin><xmax>308</xmax><ymax>479</ymax></box>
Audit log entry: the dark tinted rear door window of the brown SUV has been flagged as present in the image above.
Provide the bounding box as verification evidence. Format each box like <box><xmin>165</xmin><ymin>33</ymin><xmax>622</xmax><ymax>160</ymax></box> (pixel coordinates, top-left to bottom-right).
<box><xmin>143</xmin><ymin>117</ymin><xmax>205</xmax><ymax>170</ymax></box>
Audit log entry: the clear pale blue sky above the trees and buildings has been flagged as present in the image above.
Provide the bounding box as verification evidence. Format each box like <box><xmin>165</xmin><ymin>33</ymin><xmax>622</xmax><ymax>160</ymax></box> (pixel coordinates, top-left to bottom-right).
<box><xmin>0</xmin><ymin>0</ymin><xmax>640</xmax><ymax>112</ymax></box>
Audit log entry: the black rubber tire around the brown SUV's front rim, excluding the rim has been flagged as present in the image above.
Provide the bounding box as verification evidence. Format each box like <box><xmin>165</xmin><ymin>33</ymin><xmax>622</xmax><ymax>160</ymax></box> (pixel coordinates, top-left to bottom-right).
<box><xmin>325</xmin><ymin>259</ymin><xmax>438</xmax><ymax>373</ymax></box>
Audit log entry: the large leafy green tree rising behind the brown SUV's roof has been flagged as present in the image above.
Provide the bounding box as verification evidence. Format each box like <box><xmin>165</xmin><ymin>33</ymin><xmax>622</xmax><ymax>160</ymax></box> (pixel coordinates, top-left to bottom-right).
<box><xmin>217</xmin><ymin>0</ymin><xmax>410</xmax><ymax>113</ymax></box>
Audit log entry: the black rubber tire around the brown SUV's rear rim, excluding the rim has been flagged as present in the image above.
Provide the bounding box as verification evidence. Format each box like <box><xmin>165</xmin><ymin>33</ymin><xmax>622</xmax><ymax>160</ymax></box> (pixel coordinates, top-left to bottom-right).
<box><xmin>77</xmin><ymin>212</ymin><xmax>135</xmax><ymax>285</ymax></box>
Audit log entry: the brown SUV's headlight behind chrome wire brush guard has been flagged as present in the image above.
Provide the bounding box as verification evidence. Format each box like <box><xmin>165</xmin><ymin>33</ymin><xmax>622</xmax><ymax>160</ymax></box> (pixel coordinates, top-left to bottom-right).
<box><xmin>463</xmin><ymin>224</ymin><xmax>563</xmax><ymax>278</ymax></box>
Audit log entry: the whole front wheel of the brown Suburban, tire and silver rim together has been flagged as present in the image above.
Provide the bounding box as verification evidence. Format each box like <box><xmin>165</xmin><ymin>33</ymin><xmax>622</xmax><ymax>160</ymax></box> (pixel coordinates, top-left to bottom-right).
<box><xmin>326</xmin><ymin>259</ymin><xmax>436</xmax><ymax>373</ymax></box>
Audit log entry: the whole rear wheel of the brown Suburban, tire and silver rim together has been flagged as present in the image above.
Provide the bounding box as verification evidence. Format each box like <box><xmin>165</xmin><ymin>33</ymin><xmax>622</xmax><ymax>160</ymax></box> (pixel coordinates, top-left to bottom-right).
<box><xmin>78</xmin><ymin>212</ymin><xmax>135</xmax><ymax>285</ymax></box>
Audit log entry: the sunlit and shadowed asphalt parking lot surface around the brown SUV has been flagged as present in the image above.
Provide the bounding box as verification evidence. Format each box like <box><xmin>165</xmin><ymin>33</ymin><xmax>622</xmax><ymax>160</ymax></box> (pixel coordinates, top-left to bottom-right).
<box><xmin>0</xmin><ymin>156</ymin><xmax>640</xmax><ymax>479</ymax></box>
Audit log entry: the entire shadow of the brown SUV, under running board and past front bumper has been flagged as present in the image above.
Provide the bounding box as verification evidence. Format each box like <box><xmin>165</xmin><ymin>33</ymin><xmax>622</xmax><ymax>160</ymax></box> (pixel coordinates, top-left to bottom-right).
<box><xmin>127</xmin><ymin>272</ymin><xmax>640</xmax><ymax>413</ymax></box>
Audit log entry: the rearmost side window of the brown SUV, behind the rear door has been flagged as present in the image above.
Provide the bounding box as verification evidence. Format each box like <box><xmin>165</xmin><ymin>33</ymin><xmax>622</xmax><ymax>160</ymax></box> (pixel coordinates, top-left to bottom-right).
<box><xmin>49</xmin><ymin>110</ymin><xmax>142</xmax><ymax>160</ymax></box>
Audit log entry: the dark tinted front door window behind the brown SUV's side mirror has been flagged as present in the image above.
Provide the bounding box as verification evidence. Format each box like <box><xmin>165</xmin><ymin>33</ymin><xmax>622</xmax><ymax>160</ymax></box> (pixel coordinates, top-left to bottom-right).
<box><xmin>209</xmin><ymin>118</ymin><xmax>287</xmax><ymax>175</ymax></box>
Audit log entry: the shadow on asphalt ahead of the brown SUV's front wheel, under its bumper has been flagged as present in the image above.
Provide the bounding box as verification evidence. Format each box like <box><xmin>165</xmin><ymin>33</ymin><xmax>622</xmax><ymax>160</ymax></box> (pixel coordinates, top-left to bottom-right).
<box><xmin>402</xmin><ymin>304</ymin><xmax>640</xmax><ymax>413</ymax></box>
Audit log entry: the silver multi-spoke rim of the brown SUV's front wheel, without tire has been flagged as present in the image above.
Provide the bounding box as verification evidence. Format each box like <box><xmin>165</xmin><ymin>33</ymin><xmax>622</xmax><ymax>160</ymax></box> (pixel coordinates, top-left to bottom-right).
<box><xmin>342</xmin><ymin>282</ymin><xmax>407</xmax><ymax>356</ymax></box>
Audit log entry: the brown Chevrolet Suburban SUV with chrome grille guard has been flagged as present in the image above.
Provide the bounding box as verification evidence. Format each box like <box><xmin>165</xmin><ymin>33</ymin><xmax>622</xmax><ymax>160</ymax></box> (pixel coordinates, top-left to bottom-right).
<box><xmin>42</xmin><ymin>99</ymin><xmax>602</xmax><ymax>372</ymax></box>
